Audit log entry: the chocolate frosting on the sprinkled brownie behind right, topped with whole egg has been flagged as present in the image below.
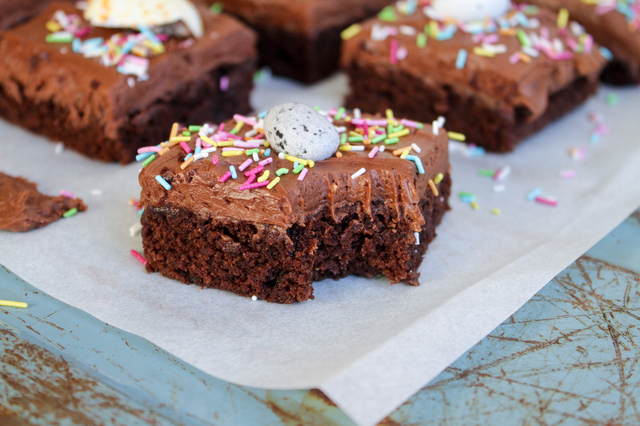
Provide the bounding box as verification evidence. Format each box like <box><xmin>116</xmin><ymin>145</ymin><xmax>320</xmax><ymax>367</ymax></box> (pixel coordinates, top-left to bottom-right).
<box><xmin>342</xmin><ymin>8</ymin><xmax>606</xmax><ymax>121</ymax></box>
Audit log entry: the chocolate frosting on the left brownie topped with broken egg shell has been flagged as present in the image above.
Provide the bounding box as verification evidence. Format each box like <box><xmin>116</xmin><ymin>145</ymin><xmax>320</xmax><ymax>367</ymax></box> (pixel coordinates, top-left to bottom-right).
<box><xmin>0</xmin><ymin>3</ymin><xmax>256</xmax><ymax>145</ymax></box>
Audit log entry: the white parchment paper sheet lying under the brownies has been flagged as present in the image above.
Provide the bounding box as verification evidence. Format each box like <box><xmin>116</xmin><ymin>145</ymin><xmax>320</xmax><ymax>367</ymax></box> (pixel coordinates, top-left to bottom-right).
<box><xmin>0</xmin><ymin>76</ymin><xmax>640</xmax><ymax>425</ymax></box>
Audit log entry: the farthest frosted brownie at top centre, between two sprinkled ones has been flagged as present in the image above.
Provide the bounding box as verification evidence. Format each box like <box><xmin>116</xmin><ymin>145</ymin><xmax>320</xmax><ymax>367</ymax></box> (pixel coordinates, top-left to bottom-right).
<box><xmin>209</xmin><ymin>0</ymin><xmax>392</xmax><ymax>84</ymax></box>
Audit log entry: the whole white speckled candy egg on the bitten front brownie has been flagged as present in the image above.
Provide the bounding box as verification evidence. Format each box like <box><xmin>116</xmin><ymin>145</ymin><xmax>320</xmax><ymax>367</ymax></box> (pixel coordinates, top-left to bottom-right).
<box><xmin>264</xmin><ymin>103</ymin><xmax>340</xmax><ymax>161</ymax></box>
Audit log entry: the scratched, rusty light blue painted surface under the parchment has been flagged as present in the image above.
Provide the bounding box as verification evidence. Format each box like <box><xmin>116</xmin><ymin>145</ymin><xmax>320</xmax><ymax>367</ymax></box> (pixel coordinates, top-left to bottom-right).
<box><xmin>0</xmin><ymin>211</ymin><xmax>640</xmax><ymax>426</ymax></box>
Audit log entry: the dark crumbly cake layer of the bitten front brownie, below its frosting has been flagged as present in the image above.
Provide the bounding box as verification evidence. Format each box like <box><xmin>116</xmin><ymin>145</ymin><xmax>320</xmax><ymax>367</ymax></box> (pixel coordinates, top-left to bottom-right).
<box><xmin>142</xmin><ymin>173</ymin><xmax>451</xmax><ymax>303</ymax></box>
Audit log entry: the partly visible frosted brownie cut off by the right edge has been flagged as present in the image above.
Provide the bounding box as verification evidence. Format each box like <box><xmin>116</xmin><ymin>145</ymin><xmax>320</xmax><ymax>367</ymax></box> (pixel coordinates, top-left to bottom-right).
<box><xmin>516</xmin><ymin>0</ymin><xmax>640</xmax><ymax>85</ymax></box>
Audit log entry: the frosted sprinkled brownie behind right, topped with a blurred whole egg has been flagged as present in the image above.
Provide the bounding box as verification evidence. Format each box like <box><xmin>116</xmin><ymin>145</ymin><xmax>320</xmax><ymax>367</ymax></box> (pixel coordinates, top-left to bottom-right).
<box><xmin>342</xmin><ymin>3</ymin><xmax>606</xmax><ymax>152</ymax></box>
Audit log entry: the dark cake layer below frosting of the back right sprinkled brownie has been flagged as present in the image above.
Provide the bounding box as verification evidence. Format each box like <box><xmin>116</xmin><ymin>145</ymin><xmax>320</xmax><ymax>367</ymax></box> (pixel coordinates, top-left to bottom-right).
<box><xmin>344</xmin><ymin>62</ymin><xmax>598</xmax><ymax>152</ymax></box>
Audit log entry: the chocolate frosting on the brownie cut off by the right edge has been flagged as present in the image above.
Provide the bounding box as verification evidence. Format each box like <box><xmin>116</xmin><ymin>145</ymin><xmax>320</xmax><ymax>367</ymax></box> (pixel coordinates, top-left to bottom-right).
<box><xmin>516</xmin><ymin>0</ymin><xmax>640</xmax><ymax>74</ymax></box>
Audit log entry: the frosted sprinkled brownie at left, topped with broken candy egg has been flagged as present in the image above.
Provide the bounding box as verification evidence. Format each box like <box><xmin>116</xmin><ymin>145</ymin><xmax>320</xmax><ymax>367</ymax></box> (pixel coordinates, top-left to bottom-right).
<box><xmin>0</xmin><ymin>3</ymin><xmax>257</xmax><ymax>163</ymax></box>
